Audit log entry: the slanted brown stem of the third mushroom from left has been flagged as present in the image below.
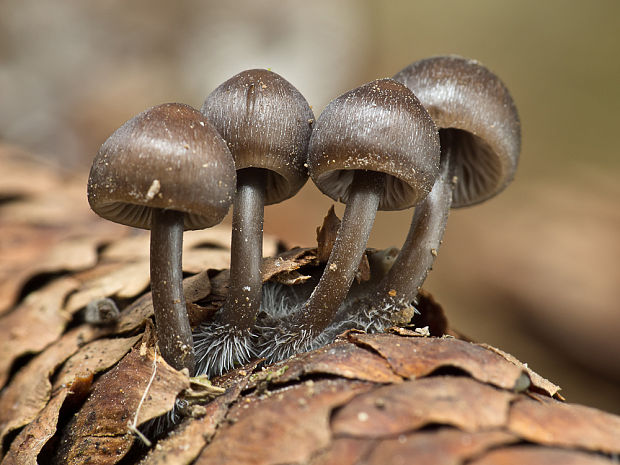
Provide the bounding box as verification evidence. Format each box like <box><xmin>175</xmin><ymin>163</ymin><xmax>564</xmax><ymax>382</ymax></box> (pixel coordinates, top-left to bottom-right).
<box><xmin>295</xmin><ymin>170</ymin><xmax>385</xmax><ymax>336</ymax></box>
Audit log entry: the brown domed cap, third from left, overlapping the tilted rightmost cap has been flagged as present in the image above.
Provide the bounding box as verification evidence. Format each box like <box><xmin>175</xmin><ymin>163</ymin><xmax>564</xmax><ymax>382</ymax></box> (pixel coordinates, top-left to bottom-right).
<box><xmin>308</xmin><ymin>79</ymin><xmax>439</xmax><ymax>210</ymax></box>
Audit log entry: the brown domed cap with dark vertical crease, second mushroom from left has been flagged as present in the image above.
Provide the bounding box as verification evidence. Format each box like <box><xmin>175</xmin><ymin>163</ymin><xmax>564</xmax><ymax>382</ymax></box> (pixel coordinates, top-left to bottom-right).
<box><xmin>201</xmin><ymin>69</ymin><xmax>314</xmax><ymax>205</ymax></box>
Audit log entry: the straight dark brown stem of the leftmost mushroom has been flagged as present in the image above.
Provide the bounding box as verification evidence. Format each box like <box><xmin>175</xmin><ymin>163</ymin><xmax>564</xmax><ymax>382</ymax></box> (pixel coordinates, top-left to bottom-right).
<box><xmin>151</xmin><ymin>208</ymin><xmax>194</xmax><ymax>373</ymax></box>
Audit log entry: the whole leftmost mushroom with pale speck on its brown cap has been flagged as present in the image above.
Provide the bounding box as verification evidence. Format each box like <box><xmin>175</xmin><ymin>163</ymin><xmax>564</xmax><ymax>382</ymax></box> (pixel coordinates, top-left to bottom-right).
<box><xmin>88</xmin><ymin>103</ymin><xmax>235</xmax><ymax>373</ymax></box>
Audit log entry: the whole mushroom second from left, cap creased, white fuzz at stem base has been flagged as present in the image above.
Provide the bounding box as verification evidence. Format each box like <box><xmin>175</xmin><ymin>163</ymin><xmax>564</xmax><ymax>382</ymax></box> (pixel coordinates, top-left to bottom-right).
<box><xmin>196</xmin><ymin>69</ymin><xmax>314</xmax><ymax>374</ymax></box>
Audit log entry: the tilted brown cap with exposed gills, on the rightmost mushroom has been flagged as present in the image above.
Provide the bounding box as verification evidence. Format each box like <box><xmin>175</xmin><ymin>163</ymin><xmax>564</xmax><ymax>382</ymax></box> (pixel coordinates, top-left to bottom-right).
<box><xmin>394</xmin><ymin>56</ymin><xmax>521</xmax><ymax>207</ymax></box>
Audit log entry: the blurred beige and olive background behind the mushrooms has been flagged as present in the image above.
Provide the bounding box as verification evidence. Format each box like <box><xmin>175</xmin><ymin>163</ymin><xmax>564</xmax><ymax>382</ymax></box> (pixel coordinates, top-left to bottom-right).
<box><xmin>0</xmin><ymin>0</ymin><xmax>620</xmax><ymax>413</ymax></box>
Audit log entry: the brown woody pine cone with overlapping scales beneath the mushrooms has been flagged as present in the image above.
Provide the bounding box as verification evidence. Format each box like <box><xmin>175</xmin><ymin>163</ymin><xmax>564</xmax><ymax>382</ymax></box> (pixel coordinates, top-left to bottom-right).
<box><xmin>0</xmin><ymin>144</ymin><xmax>620</xmax><ymax>465</ymax></box>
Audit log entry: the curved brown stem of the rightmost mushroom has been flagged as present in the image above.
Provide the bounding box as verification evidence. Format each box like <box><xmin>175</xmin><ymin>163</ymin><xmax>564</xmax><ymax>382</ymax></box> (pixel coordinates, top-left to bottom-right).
<box><xmin>373</xmin><ymin>136</ymin><xmax>455</xmax><ymax>314</ymax></box>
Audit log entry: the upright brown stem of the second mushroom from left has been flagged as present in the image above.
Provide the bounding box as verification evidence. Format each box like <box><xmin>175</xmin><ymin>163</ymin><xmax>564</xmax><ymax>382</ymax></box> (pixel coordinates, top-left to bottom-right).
<box><xmin>220</xmin><ymin>168</ymin><xmax>265</xmax><ymax>330</ymax></box>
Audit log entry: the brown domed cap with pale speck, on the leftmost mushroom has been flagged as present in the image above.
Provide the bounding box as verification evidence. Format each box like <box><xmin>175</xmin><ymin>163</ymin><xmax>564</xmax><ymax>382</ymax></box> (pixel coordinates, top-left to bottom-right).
<box><xmin>88</xmin><ymin>103</ymin><xmax>236</xmax><ymax>229</ymax></box>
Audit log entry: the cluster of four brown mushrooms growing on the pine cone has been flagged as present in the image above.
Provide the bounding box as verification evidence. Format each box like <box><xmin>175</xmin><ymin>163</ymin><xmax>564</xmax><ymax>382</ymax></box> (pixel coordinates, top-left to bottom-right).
<box><xmin>88</xmin><ymin>57</ymin><xmax>520</xmax><ymax>375</ymax></box>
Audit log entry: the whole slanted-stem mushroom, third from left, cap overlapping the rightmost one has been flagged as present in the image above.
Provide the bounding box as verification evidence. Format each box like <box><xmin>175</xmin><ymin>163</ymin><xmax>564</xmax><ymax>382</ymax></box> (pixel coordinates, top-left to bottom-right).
<box><xmin>261</xmin><ymin>79</ymin><xmax>439</xmax><ymax>360</ymax></box>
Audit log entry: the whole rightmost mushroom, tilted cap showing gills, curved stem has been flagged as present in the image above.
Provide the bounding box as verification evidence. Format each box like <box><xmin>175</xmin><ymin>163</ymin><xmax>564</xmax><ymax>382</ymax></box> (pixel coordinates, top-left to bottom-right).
<box><xmin>371</xmin><ymin>56</ymin><xmax>521</xmax><ymax>320</ymax></box>
